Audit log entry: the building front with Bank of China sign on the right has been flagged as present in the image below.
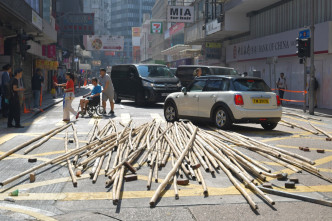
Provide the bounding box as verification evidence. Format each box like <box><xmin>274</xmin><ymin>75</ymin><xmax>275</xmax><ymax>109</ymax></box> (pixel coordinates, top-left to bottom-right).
<box><xmin>219</xmin><ymin>0</ymin><xmax>332</xmax><ymax>109</ymax></box>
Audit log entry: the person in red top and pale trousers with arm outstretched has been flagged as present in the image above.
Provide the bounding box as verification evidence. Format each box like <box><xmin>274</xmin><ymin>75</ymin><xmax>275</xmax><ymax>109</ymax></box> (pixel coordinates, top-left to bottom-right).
<box><xmin>54</xmin><ymin>72</ymin><xmax>79</xmax><ymax>122</ymax></box>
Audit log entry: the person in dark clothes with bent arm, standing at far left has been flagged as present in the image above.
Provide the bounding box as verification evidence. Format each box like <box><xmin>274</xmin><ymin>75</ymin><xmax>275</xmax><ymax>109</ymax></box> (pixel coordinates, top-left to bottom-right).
<box><xmin>7</xmin><ymin>68</ymin><xmax>25</xmax><ymax>128</ymax></box>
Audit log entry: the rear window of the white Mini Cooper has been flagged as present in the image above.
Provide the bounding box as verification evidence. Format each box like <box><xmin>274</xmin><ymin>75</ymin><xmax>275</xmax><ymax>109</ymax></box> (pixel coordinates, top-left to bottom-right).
<box><xmin>234</xmin><ymin>79</ymin><xmax>271</xmax><ymax>92</ymax></box>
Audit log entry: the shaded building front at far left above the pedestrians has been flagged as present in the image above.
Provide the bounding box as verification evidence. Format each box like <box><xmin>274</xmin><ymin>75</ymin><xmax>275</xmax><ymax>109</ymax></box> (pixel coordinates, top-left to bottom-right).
<box><xmin>0</xmin><ymin>0</ymin><xmax>57</xmax><ymax>102</ymax></box>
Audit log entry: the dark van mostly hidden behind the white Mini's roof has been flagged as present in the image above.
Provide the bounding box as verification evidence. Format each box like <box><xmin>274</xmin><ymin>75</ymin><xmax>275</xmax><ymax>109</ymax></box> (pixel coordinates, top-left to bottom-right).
<box><xmin>175</xmin><ymin>65</ymin><xmax>238</xmax><ymax>87</ymax></box>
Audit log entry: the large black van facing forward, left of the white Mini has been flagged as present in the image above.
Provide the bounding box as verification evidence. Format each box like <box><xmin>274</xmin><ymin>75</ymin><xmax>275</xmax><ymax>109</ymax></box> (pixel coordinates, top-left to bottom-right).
<box><xmin>111</xmin><ymin>64</ymin><xmax>181</xmax><ymax>105</ymax></box>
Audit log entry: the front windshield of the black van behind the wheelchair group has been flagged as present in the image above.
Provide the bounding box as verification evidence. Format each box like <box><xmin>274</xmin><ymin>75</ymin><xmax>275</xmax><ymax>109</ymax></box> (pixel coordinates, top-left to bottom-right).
<box><xmin>137</xmin><ymin>65</ymin><xmax>174</xmax><ymax>78</ymax></box>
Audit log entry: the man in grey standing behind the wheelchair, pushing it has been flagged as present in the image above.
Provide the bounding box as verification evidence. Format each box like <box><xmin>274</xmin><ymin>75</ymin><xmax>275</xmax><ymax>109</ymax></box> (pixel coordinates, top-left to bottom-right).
<box><xmin>99</xmin><ymin>68</ymin><xmax>114</xmax><ymax>115</ymax></box>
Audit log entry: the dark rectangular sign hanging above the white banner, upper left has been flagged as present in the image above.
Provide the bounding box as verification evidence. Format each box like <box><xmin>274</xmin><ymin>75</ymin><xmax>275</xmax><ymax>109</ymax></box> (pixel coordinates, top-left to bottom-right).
<box><xmin>60</xmin><ymin>13</ymin><xmax>94</xmax><ymax>35</ymax></box>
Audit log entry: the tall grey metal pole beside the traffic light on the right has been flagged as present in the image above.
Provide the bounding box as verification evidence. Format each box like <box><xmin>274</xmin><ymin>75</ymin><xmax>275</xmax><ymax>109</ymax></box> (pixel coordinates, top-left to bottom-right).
<box><xmin>309</xmin><ymin>0</ymin><xmax>315</xmax><ymax>115</ymax></box>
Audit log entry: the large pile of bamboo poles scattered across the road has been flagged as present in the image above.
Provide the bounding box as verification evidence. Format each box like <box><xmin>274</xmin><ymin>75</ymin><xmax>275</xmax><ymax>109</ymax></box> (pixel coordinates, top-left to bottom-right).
<box><xmin>0</xmin><ymin>120</ymin><xmax>332</xmax><ymax>209</ymax></box>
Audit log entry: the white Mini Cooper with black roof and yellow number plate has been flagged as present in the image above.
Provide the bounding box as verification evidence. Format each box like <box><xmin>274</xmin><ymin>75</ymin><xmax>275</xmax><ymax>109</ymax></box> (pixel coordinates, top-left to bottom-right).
<box><xmin>164</xmin><ymin>76</ymin><xmax>282</xmax><ymax>130</ymax></box>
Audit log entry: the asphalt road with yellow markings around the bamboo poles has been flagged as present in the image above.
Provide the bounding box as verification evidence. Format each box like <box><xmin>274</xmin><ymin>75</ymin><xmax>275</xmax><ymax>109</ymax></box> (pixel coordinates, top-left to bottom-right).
<box><xmin>0</xmin><ymin>87</ymin><xmax>332</xmax><ymax>220</ymax></box>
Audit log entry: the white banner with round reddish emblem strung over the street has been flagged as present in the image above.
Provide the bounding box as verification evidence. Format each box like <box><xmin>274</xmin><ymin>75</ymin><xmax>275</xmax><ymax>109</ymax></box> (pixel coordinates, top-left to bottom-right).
<box><xmin>83</xmin><ymin>35</ymin><xmax>124</xmax><ymax>51</ymax></box>
